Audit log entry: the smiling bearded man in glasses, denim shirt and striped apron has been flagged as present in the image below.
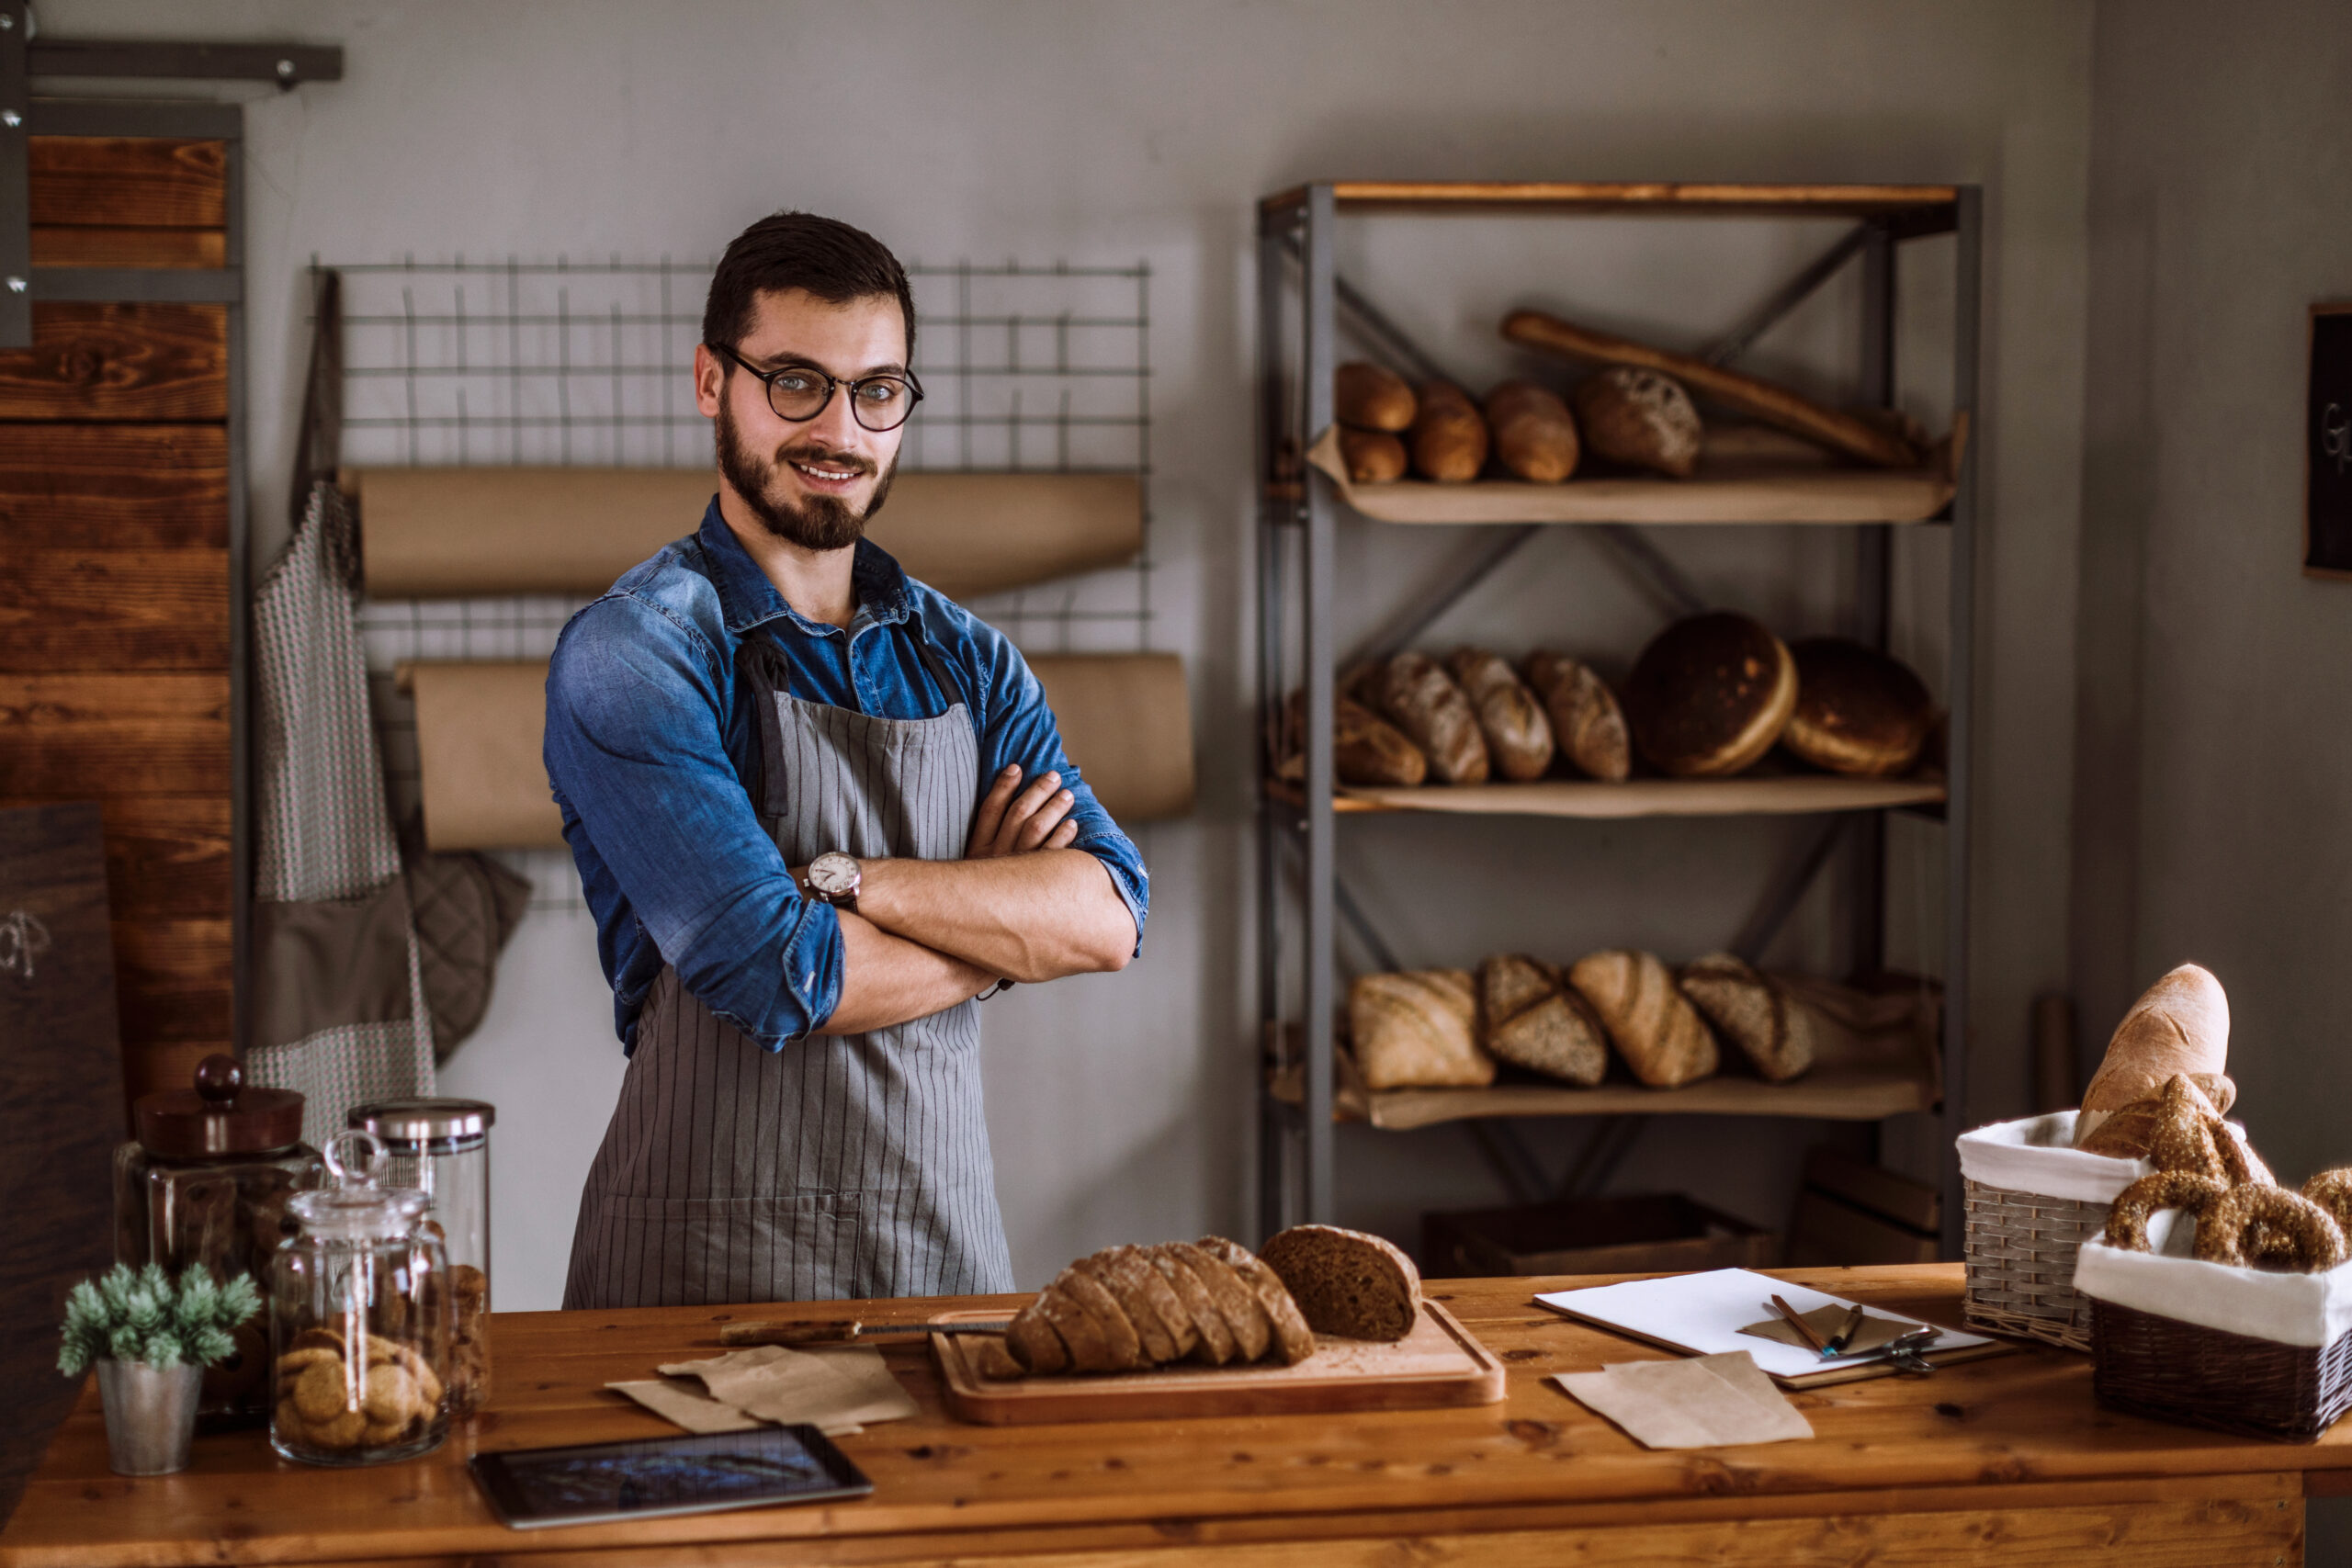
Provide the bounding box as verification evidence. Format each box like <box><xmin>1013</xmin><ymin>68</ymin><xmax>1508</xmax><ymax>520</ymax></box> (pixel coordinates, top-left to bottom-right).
<box><xmin>546</xmin><ymin>211</ymin><xmax>1148</xmax><ymax>1307</ymax></box>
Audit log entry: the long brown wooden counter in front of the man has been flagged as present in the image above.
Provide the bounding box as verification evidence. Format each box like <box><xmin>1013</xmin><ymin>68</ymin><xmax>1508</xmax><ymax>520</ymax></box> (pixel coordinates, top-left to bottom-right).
<box><xmin>0</xmin><ymin>1265</ymin><xmax>2352</xmax><ymax>1568</ymax></box>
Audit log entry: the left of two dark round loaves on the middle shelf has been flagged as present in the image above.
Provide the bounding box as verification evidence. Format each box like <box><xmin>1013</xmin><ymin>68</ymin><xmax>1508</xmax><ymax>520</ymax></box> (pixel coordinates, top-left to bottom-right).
<box><xmin>1625</xmin><ymin>609</ymin><xmax>1797</xmax><ymax>778</ymax></box>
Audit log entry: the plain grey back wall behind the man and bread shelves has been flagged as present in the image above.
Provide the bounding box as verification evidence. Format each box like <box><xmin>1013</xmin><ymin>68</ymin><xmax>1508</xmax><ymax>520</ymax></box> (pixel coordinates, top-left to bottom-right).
<box><xmin>40</xmin><ymin>0</ymin><xmax>2091</xmax><ymax>1307</ymax></box>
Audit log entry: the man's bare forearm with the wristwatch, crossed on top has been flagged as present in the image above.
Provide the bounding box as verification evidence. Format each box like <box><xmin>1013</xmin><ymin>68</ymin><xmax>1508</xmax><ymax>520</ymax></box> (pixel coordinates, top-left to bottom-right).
<box><xmin>858</xmin><ymin>849</ymin><xmax>1136</xmax><ymax>983</ymax></box>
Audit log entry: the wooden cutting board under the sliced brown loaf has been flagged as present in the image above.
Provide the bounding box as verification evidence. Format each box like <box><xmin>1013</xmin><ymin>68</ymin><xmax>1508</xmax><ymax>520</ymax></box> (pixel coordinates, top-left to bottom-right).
<box><xmin>932</xmin><ymin>1303</ymin><xmax>1503</xmax><ymax>1427</ymax></box>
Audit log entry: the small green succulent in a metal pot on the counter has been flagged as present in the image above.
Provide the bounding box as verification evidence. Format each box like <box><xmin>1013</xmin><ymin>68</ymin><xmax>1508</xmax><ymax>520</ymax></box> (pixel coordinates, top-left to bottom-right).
<box><xmin>56</xmin><ymin>1262</ymin><xmax>261</xmax><ymax>1476</ymax></box>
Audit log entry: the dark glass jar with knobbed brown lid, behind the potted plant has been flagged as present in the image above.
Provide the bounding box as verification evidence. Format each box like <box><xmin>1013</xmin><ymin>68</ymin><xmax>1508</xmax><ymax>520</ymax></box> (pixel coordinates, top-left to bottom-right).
<box><xmin>115</xmin><ymin>1055</ymin><xmax>322</xmax><ymax>1427</ymax></box>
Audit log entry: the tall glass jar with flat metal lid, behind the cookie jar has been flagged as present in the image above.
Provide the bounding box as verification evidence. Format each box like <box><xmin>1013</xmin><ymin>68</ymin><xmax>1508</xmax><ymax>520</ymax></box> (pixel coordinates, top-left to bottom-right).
<box><xmin>350</xmin><ymin>1100</ymin><xmax>499</xmax><ymax>1416</ymax></box>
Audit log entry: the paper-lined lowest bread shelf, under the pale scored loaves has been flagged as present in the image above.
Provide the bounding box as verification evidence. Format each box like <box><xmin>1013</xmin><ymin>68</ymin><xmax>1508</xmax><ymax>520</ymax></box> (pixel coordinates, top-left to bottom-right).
<box><xmin>1268</xmin><ymin>1063</ymin><xmax>1938</xmax><ymax>1134</ymax></box>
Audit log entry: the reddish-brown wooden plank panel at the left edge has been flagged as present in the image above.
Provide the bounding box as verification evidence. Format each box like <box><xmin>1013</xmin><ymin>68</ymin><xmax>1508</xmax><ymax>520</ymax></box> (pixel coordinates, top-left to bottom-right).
<box><xmin>0</xmin><ymin>136</ymin><xmax>232</xmax><ymax>1096</ymax></box>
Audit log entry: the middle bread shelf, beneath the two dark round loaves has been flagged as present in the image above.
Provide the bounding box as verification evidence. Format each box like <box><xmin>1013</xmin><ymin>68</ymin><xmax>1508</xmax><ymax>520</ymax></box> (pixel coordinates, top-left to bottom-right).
<box><xmin>1268</xmin><ymin>773</ymin><xmax>1945</xmax><ymax>820</ymax></box>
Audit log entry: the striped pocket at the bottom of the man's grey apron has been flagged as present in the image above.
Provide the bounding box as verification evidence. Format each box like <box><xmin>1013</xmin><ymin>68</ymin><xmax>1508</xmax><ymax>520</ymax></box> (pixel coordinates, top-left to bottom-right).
<box><xmin>564</xmin><ymin>1192</ymin><xmax>865</xmax><ymax>1307</ymax></box>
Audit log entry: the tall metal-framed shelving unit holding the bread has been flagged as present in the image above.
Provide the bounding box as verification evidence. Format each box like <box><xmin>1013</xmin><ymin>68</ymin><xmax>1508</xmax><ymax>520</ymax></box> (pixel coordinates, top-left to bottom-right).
<box><xmin>1256</xmin><ymin>181</ymin><xmax>1983</xmax><ymax>1258</ymax></box>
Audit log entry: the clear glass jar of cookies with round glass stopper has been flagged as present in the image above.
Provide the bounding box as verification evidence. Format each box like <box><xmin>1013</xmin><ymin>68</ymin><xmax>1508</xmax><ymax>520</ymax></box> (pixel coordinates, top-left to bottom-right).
<box><xmin>270</xmin><ymin>1134</ymin><xmax>449</xmax><ymax>1464</ymax></box>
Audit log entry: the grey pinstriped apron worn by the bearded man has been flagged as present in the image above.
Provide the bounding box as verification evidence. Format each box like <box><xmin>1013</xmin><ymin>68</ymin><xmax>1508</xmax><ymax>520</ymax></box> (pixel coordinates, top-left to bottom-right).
<box><xmin>564</xmin><ymin>623</ymin><xmax>1013</xmax><ymax>1309</ymax></box>
